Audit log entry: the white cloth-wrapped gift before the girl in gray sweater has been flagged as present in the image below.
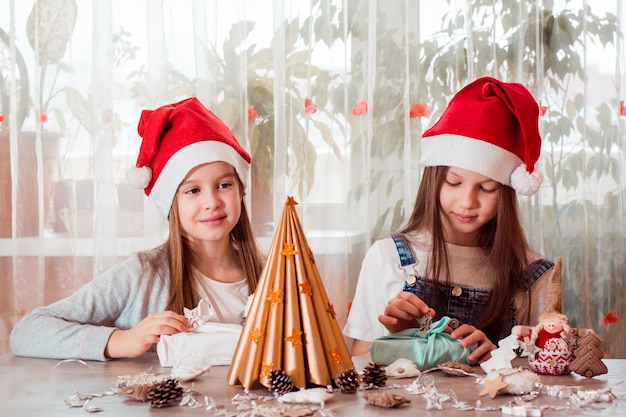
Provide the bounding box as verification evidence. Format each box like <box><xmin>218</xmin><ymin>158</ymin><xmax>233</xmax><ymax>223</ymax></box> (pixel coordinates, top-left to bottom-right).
<box><xmin>157</xmin><ymin>300</ymin><xmax>242</xmax><ymax>367</ymax></box>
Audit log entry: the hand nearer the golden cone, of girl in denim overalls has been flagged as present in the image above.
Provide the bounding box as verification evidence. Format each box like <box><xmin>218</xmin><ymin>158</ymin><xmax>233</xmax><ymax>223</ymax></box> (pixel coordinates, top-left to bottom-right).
<box><xmin>378</xmin><ymin>291</ymin><xmax>435</xmax><ymax>333</ymax></box>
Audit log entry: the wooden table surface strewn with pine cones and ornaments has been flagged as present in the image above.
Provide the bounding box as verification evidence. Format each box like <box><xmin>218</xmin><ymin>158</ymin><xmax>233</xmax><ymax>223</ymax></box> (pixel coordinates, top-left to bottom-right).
<box><xmin>0</xmin><ymin>353</ymin><xmax>626</xmax><ymax>417</ymax></box>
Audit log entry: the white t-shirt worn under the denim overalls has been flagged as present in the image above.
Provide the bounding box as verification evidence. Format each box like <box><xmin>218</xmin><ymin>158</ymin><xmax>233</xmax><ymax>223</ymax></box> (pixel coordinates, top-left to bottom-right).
<box><xmin>343</xmin><ymin>231</ymin><xmax>547</xmax><ymax>342</ymax></box>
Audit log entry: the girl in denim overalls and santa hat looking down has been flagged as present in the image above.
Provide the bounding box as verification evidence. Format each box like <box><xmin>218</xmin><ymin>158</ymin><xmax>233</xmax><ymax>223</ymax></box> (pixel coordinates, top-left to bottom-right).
<box><xmin>344</xmin><ymin>77</ymin><xmax>553</xmax><ymax>362</ymax></box>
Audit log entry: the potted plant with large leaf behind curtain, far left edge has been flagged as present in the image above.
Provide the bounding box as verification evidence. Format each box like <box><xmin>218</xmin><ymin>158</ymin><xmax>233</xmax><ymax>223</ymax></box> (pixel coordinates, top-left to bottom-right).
<box><xmin>0</xmin><ymin>0</ymin><xmax>76</xmax><ymax>237</ymax></box>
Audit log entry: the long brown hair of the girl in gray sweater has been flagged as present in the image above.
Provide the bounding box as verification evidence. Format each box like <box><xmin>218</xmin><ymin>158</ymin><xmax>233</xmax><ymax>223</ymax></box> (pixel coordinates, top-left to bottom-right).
<box><xmin>164</xmin><ymin>183</ymin><xmax>264</xmax><ymax>314</ymax></box>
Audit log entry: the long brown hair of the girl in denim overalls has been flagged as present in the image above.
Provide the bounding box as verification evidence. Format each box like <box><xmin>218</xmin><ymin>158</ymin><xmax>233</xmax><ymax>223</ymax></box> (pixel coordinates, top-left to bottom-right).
<box><xmin>400</xmin><ymin>166</ymin><xmax>530</xmax><ymax>340</ymax></box>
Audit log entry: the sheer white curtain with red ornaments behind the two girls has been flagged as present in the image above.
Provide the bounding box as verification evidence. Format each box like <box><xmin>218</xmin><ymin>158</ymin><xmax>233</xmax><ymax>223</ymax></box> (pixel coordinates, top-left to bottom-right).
<box><xmin>0</xmin><ymin>0</ymin><xmax>626</xmax><ymax>357</ymax></box>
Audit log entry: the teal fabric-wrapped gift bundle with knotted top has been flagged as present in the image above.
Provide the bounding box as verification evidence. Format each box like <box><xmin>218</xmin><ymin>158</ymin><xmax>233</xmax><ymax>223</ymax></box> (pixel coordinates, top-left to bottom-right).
<box><xmin>370</xmin><ymin>316</ymin><xmax>478</xmax><ymax>371</ymax></box>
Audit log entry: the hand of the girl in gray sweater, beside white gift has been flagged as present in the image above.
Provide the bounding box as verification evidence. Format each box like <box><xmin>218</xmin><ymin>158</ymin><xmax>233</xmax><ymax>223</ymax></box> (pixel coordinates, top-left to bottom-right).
<box><xmin>104</xmin><ymin>311</ymin><xmax>189</xmax><ymax>358</ymax></box>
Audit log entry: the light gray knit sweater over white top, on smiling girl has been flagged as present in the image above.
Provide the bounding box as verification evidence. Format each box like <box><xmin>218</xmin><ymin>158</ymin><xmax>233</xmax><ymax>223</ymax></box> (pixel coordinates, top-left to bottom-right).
<box><xmin>11</xmin><ymin>247</ymin><xmax>169</xmax><ymax>361</ymax></box>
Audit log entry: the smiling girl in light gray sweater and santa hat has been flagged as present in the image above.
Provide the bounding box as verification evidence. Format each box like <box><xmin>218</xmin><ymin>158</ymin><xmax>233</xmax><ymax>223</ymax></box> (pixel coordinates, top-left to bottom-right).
<box><xmin>11</xmin><ymin>98</ymin><xmax>263</xmax><ymax>360</ymax></box>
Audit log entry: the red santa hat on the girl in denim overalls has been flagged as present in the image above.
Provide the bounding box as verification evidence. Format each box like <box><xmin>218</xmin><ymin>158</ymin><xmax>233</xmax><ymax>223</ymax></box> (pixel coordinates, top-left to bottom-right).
<box><xmin>421</xmin><ymin>77</ymin><xmax>543</xmax><ymax>195</ymax></box>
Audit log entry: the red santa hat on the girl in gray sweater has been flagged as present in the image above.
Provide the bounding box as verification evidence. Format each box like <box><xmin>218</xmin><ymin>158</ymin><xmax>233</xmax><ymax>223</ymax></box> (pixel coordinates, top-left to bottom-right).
<box><xmin>127</xmin><ymin>97</ymin><xmax>250</xmax><ymax>217</ymax></box>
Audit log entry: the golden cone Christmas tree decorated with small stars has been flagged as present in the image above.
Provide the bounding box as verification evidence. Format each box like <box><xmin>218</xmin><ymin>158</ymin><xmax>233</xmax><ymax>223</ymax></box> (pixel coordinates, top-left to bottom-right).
<box><xmin>228</xmin><ymin>197</ymin><xmax>354</xmax><ymax>389</ymax></box>
